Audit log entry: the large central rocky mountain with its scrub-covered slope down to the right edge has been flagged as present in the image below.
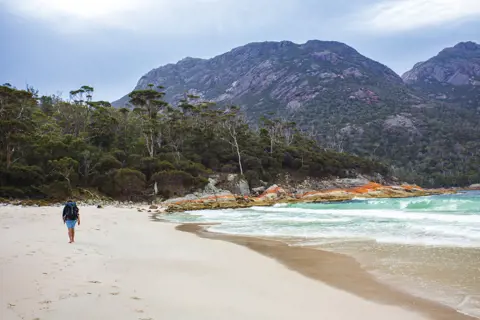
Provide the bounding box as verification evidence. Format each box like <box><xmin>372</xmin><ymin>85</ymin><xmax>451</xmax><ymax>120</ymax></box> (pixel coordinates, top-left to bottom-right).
<box><xmin>113</xmin><ymin>40</ymin><xmax>480</xmax><ymax>186</ymax></box>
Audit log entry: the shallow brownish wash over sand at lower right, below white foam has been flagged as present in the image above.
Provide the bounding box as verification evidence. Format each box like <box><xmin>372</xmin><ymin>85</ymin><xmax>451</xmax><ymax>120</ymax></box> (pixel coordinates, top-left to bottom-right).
<box><xmin>315</xmin><ymin>239</ymin><xmax>480</xmax><ymax>318</ymax></box>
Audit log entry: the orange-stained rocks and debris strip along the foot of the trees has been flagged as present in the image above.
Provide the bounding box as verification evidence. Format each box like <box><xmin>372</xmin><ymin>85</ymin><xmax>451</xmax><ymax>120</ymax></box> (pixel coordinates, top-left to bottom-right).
<box><xmin>0</xmin><ymin>182</ymin><xmax>462</xmax><ymax>213</ymax></box>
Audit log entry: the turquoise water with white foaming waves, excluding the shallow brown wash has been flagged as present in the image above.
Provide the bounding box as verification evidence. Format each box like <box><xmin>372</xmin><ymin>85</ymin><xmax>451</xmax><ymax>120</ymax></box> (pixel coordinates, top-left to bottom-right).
<box><xmin>165</xmin><ymin>192</ymin><xmax>480</xmax><ymax>247</ymax></box>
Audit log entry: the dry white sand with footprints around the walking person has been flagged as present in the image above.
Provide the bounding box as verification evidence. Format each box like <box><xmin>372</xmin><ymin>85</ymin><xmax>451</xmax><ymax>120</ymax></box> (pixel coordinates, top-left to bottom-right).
<box><xmin>0</xmin><ymin>207</ymin><xmax>425</xmax><ymax>320</ymax></box>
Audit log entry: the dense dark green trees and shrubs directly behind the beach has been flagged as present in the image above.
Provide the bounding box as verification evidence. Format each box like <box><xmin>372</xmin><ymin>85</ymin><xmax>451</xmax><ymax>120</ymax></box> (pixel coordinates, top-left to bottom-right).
<box><xmin>0</xmin><ymin>84</ymin><xmax>388</xmax><ymax>200</ymax></box>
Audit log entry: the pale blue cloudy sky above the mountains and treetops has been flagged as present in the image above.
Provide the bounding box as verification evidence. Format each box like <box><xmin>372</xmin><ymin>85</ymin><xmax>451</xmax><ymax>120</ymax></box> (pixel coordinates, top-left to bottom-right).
<box><xmin>0</xmin><ymin>0</ymin><xmax>480</xmax><ymax>101</ymax></box>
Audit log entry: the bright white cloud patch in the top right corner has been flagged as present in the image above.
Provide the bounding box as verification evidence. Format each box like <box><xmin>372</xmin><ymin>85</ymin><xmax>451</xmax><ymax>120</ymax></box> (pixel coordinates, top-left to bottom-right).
<box><xmin>354</xmin><ymin>0</ymin><xmax>480</xmax><ymax>33</ymax></box>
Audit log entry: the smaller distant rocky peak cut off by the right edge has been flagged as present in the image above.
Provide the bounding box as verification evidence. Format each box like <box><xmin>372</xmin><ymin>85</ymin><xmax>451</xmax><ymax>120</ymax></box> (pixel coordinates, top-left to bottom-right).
<box><xmin>402</xmin><ymin>42</ymin><xmax>480</xmax><ymax>108</ymax></box>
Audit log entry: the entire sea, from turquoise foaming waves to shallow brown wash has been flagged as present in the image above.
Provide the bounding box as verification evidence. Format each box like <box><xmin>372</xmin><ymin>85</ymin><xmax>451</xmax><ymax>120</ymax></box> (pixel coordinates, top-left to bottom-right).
<box><xmin>167</xmin><ymin>192</ymin><xmax>480</xmax><ymax>318</ymax></box>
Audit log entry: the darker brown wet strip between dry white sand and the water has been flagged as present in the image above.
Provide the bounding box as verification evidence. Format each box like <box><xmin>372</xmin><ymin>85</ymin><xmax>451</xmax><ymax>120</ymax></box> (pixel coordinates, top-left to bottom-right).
<box><xmin>176</xmin><ymin>224</ymin><xmax>477</xmax><ymax>320</ymax></box>
